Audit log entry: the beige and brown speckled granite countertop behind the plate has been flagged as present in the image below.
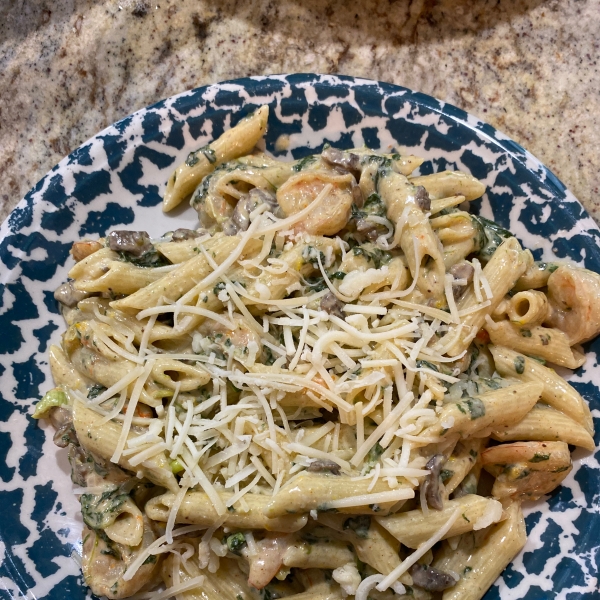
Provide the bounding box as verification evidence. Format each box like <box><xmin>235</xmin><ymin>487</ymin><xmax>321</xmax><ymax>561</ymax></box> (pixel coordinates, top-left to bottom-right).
<box><xmin>0</xmin><ymin>0</ymin><xmax>600</xmax><ymax>222</ymax></box>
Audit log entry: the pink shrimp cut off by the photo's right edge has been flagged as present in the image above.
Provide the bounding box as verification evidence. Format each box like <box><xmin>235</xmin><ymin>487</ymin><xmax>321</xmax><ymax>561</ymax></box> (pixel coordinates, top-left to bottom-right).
<box><xmin>545</xmin><ymin>265</ymin><xmax>600</xmax><ymax>345</ymax></box>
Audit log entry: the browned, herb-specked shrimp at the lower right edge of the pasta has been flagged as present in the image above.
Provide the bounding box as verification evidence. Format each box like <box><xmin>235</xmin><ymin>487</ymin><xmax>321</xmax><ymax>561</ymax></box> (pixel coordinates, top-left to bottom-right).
<box><xmin>481</xmin><ymin>442</ymin><xmax>573</xmax><ymax>500</ymax></box>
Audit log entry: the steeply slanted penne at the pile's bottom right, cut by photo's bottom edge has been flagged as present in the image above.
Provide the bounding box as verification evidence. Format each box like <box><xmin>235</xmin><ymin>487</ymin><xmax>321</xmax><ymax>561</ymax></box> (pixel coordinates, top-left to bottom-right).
<box><xmin>434</xmin><ymin>502</ymin><xmax>527</xmax><ymax>600</ymax></box>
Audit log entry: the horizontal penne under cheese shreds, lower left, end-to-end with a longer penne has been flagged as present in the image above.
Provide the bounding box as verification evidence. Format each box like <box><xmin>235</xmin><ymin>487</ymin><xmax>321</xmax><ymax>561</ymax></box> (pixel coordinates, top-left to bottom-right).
<box><xmin>145</xmin><ymin>492</ymin><xmax>307</xmax><ymax>532</ymax></box>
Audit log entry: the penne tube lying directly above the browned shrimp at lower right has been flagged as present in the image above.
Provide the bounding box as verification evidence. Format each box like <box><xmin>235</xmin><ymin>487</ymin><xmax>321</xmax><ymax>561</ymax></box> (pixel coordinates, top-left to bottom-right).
<box><xmin>492</xmin><ymin>404</ymin><xmax>596</xmax><ymax>451</ymax></box>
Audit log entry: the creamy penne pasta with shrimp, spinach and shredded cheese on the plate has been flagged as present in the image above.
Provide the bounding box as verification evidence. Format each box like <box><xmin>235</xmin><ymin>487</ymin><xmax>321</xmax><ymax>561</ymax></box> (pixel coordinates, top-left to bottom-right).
<box><xmin>34</xmin><ymin>106</ymin><xmax>600</xmax><ymax>600</ymax></box>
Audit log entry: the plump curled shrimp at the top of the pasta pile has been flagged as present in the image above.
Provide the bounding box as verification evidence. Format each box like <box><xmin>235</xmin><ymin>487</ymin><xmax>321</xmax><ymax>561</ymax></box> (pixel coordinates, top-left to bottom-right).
<box><xmin>277</xmin><ymin>171</ymin><xmax>356</xmax><ymax>235</ymax></box>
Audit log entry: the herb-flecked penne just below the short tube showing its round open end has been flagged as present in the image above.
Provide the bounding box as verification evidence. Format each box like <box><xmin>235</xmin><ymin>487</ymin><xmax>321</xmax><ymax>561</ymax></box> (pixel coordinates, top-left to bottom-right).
<box><xmin>485</xmin><ymin>321</ymin><xmax>585</xmax><ymax>369</ymax></box>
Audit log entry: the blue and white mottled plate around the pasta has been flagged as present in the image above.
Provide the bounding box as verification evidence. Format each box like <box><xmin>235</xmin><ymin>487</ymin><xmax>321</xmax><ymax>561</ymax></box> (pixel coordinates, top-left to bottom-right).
<box><xmin>0</xmin><ymin>75</ymin><xmax>600</xmax><ymax>600</ymax></box>
